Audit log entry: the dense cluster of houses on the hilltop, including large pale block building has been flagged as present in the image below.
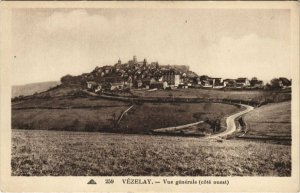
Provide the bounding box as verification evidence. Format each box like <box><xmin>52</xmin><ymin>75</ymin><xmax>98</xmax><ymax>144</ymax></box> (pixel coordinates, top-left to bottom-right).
<box><xmin>87</xmin><ymin>56</ymin><xmax>184</xmax><ymax>92</ymax></box>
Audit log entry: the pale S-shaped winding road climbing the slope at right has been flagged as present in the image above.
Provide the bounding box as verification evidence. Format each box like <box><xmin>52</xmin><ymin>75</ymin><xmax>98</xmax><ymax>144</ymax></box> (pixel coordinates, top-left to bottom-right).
<box><xmin>207</xmin><ymin>104</ymin><xmax>254</xmax><ymax>139</ymax></box>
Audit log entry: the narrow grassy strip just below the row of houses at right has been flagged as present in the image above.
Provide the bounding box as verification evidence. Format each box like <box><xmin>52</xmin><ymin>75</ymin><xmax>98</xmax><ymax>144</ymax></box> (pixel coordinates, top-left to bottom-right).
<box><xmin>132</xmin><ymin>88</ymin><xmax>291</xmax><ymax>103</ymax></box>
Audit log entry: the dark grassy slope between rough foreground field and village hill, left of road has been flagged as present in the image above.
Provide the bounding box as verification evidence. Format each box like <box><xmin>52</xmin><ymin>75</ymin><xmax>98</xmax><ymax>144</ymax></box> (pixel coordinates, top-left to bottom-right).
<box><xmin>12</xmin><ymin>96</ymin><xmax>241</xmax><ymax>133</ymax></box>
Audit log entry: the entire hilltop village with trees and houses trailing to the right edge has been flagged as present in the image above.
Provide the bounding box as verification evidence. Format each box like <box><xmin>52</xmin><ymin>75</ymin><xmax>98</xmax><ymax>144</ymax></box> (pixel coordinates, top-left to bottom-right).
<box><xmin>61</xmin><ymin>56</ymin><xmax>291</xmax><ymax>92</ymax></box>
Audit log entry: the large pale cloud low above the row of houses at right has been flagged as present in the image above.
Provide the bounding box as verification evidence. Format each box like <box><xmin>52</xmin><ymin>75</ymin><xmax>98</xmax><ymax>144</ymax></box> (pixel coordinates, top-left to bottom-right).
<box><xmin>192</xmin><ymin>33</ymin><xmax>290</xmax><ymax>78</ymax></box>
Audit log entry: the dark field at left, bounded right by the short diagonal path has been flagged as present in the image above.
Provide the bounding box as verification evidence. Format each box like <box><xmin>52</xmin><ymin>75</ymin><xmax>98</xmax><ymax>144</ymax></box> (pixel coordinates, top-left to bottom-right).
<box><xmin>12</xmin><ymin>107</ymin><xmax>127</xmax><ymax>131</ymax></box>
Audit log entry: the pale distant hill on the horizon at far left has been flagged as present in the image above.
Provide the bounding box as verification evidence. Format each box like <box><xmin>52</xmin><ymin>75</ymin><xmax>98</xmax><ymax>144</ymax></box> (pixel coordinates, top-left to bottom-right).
<box><xmin>11</xmin><ymin>81</ymin><xmax>60</xmax><ymax>98</ymax></box>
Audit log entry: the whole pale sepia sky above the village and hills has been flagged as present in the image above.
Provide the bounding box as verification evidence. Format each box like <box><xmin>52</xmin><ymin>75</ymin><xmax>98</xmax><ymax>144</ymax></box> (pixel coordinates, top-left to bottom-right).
<box><xmin>12</xmin><ymin>8</ymin><xmax>291</xmax><ymax>85</ymax></box>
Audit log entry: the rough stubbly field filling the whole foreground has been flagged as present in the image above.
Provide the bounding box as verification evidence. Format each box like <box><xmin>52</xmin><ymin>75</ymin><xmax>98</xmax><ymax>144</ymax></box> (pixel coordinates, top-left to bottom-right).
<box><xmin>11</xmin><ymin>130</ymin><xmax>291</xmax><ymax>176</ymax></box>
